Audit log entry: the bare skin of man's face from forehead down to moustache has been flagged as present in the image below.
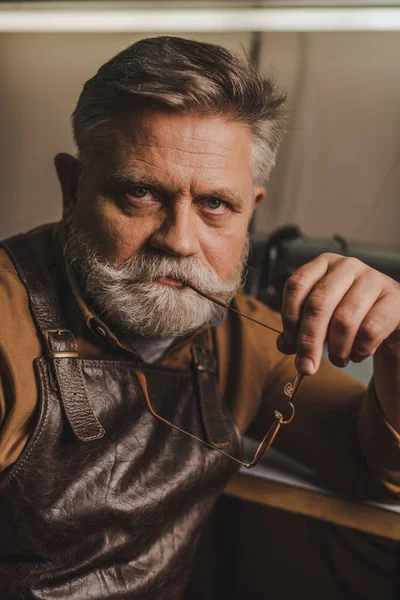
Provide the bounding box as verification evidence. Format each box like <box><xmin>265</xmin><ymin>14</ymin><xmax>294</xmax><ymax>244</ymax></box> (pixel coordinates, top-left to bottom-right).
<box><xmin>76</xmin><ymin>113</ymin><xmax>262</xmax><ymax>279</ymax></box>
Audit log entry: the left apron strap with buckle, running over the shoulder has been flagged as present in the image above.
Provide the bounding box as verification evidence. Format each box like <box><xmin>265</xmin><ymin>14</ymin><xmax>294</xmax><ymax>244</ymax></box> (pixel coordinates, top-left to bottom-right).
<box><xmin>0</xmin><ymin>234</ymin><xmax>104</xmax><ymax>442</ymax></box>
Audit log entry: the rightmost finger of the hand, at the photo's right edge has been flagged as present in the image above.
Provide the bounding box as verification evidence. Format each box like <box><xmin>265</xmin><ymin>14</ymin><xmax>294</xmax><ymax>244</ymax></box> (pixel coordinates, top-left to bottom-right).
<box><xmin>350</xmin><ymin>294</ymin><xmax>398</xmax><ymax>362</ymax></box>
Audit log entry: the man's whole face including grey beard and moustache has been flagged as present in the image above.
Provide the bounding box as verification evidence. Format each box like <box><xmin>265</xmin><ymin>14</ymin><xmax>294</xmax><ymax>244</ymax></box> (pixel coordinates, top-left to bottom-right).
<box><xmin>58</xmin><ymin>112</ymin><xmax>264</xmax><ymax>336</ymax></box>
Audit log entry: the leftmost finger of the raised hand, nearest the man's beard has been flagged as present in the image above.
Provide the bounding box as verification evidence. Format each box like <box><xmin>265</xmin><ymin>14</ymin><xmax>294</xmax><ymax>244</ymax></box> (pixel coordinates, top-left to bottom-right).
<box><xmin>281</xmin><ymin>254</ymin><xmax>330</xmax><ymax>346</ymax></box>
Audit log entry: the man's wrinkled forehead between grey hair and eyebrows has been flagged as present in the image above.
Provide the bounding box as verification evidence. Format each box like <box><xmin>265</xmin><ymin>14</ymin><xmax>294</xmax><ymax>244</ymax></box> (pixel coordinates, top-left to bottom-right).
<box><xmin>108</xmin><ymin>112</ymin><xmax>252</xmax><ymax>188</ymax></box>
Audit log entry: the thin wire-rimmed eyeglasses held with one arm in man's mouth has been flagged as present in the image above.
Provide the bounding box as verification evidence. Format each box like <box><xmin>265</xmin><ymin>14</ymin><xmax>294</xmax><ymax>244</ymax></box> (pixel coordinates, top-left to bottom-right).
<box><xmin>136</xmin><ymin>283</ymin><xmax>304</xmax><ymax>469</ymax></box>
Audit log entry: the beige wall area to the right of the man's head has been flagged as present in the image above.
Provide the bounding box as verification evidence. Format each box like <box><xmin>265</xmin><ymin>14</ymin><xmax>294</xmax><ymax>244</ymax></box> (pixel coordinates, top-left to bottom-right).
<box><xmin>259</xmin><ymin>33</ymin><xmax>400</xmax><ymax>244</ymax></box>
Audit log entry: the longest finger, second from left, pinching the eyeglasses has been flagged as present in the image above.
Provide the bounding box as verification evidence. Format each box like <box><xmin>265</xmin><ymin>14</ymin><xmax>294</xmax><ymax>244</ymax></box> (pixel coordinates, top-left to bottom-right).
<box><xmin>296</xmin><ymin>258</ymin><xmax>364</xmax><ymax>375</ymax></box>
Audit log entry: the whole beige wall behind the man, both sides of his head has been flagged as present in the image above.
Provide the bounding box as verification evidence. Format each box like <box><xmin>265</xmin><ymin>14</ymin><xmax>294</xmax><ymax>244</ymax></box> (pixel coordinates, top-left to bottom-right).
<box><xmin>0</xmin><ymin>33</ymin><xmax>400</xmax><ymax>242</ymax></box>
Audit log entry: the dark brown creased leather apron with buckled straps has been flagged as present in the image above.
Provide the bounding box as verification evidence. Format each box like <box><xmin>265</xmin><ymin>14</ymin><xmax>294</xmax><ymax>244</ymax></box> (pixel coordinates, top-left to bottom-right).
<box><xmin>0</xmin><ymin>236</ymin><xmax>241</xmax><ymax>600</ymax></box>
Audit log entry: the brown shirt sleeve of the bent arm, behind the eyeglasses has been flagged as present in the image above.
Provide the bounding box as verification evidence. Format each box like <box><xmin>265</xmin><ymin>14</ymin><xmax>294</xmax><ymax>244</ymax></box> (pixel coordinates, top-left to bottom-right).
<box><xmin>249</xmin><ymin>357</ymin><xmax>400</xmax><ymax>500</ymax></box>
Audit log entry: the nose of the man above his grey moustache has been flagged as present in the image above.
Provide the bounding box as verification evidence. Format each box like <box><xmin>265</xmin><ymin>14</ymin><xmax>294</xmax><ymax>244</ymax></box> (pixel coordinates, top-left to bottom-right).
<box><xmin>150</xmin><ymin>207</ymin><xmax>200</xmax><ymax>256</ymax></box>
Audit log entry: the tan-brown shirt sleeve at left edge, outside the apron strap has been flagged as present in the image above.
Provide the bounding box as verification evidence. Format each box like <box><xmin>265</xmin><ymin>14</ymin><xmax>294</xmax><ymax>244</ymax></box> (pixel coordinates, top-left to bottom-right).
<box><xmin>0</xmin><ymin>251</ymin><xmax>42</xmax><ymax>472</ymax></box>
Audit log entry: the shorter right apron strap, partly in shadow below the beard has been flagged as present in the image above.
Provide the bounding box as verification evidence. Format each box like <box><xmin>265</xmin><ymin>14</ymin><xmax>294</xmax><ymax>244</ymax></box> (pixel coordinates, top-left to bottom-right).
<box><xmin>192</xmin><ymin>332</ymin><xmax>233</xmax><ymax>448</ymax></box>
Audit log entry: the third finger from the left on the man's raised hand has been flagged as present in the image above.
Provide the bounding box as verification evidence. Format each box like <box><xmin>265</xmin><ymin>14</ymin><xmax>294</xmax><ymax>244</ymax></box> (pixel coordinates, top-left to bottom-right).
<box><xmin>328</xmin><ymin>270</ymin><xmax>382</xmax><ymax>367</ymax></box>
